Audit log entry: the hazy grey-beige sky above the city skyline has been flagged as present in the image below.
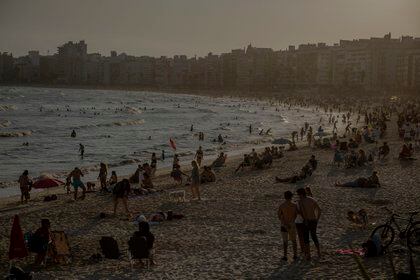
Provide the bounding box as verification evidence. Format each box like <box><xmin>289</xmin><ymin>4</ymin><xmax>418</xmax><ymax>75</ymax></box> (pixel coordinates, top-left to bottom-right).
<box><xmin>0</xmin><ymin>0</ymin><xmax>420</xmax><ymax>56</ymax></box>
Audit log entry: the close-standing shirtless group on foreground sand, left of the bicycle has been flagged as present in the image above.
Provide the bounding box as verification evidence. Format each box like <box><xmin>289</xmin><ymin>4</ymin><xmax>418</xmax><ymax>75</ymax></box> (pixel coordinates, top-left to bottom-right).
<box><xmin>278</xmin><ymin>188</ymin><xmax>321</xmax><ymax>261</ymax></box>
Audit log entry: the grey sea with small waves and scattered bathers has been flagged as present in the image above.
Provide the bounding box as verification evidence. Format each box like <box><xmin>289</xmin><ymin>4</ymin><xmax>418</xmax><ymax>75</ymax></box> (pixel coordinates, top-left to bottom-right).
<box><xmin>0</xmin><ymin>87</ymin><xmax>325</xmax><ymax>196</ymax></box>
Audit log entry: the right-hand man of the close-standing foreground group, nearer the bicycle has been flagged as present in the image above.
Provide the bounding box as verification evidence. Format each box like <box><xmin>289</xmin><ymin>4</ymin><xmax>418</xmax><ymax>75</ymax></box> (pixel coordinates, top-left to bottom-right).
<box><xmin>296</xmin><ymin>188</ymin><xmax>321</xmax><ymax>260</ymax></box>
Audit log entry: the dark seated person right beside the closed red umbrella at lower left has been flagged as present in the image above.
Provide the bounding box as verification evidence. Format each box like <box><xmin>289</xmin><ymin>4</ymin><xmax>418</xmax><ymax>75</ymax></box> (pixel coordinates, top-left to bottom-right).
<box><xmin>31</xmin><ymin>219</ymin><xmax>52</xmax><ymax>265</ymax></box>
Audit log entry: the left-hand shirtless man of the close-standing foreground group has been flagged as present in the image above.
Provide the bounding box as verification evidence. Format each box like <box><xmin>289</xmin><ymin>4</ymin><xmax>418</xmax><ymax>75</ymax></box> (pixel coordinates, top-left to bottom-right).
<box><xmin>278</xmin><ymin>191</ymin><xmax>298</xmax><ymax>261</ymax></box>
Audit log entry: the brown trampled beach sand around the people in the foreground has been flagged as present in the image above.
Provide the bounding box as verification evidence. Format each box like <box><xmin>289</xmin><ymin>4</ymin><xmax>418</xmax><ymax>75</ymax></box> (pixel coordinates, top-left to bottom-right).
<box><xmin>0</xmin><ymin>112</ymin><xmax>420</xmax><ymax>279</ymax></box>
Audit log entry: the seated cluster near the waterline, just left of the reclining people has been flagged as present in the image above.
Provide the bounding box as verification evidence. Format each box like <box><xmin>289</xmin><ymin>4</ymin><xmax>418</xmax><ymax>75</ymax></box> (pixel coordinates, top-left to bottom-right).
<box><xmin>235</xmin><ymin>146</ymin><xmax>283</xmax><ymax>173</ymax></box>
